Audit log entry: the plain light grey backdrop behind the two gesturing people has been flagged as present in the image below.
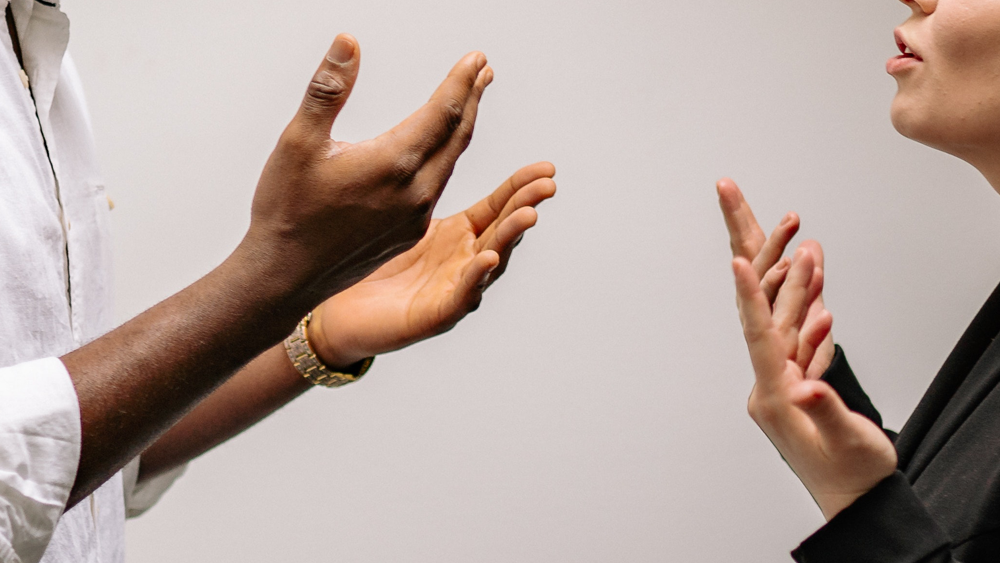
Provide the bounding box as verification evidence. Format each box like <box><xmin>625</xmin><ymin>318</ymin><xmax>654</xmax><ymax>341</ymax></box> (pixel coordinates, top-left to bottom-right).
<box><xmin>58</xmin><ymin>0</ymin><xmax>1000</xmax><ymax>563</ymax></box>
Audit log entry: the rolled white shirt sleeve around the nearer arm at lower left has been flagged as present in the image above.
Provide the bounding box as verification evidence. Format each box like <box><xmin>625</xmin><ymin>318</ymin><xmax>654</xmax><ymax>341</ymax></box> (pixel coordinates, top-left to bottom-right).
<box><xmin>0</xmin><ymin>358</ymin><xmax>82</xmax><ymax>563</ymax></box>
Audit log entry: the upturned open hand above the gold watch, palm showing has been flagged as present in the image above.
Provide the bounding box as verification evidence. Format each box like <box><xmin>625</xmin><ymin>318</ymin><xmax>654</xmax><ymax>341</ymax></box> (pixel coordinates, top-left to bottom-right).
<box><xmin>309</xmin><ymin>162</ymin><xmax>556</xmax><ymax>368</ymax></box>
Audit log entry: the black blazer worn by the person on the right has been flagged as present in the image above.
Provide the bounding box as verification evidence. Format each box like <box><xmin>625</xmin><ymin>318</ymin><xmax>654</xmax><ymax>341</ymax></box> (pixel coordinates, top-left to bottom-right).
<box><xmin>792</xmin><ymin>287</ymin><xmax>1000</xmax><ymax>563</ymax></box>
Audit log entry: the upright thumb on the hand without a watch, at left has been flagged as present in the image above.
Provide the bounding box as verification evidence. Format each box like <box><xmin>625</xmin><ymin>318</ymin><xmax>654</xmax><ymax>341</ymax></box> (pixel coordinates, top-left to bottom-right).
<box><xmin>295</xmin><ymin>33</ymin><xmax>361</xmax><ymax>140</ymax></box>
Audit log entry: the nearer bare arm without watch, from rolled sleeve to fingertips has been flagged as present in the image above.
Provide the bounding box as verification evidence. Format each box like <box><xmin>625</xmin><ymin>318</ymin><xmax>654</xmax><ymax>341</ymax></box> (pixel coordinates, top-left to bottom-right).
<box><xmin>62</xmin><ymin>35</ymin><xmax>493</xmax><ymax>507</ymax></box>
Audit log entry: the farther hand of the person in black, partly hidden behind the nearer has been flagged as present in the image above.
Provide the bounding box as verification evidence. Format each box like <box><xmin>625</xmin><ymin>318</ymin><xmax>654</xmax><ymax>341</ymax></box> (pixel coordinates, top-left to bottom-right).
<box><xmin>716</xmin><ymin>178</ymin><xmax>836</xmax><ymax>379</ymax></box>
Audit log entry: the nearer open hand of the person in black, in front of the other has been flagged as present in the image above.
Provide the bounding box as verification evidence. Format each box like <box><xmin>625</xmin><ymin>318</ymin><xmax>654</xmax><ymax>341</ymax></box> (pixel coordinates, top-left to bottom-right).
<box><xmin>733</xmin><ymin>243</ymin><xmax>896</xmax><ymax>519</ymax></box>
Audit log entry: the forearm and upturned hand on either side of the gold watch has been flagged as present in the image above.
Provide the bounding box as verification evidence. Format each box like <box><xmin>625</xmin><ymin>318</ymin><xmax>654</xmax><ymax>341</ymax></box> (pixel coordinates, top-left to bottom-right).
<box><xmin>139</xmin><ymin>162</ymin><xmax>556</xmax><ymax>481</ymax></box>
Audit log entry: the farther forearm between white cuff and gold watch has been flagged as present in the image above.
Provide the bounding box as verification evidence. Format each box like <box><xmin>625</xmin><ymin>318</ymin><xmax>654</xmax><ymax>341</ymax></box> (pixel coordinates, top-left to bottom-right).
<box><xmin>139</xmin><ymin>345</ymin><xmax>313</xmax><ymax>482</ymax></box>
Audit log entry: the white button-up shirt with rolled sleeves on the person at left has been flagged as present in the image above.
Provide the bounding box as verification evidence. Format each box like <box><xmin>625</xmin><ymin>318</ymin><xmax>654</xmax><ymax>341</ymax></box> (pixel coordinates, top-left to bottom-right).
<box><xmin>0</xmin><ymin>0</ymin><xmax>179</xmax><ymax>563</ymax></box>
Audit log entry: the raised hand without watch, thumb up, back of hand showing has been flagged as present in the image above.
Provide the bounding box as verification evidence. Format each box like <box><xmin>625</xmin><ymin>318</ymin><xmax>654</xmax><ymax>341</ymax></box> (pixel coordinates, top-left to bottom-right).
<box><xmin>237</xmin><ymin>35</ymin><xmax>493</xmax><ymax>308</ymax></box>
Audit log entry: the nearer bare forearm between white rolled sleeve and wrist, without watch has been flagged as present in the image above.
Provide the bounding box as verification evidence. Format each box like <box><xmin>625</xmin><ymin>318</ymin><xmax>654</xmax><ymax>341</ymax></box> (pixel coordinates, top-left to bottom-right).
<box><xmin>62</xmin><ymin>245</ymin><xmax>306</xmax><ymax>507</ymax></box>
